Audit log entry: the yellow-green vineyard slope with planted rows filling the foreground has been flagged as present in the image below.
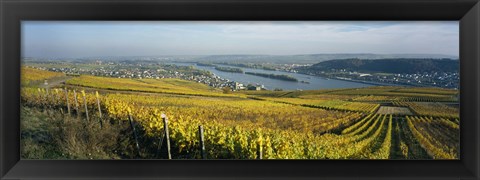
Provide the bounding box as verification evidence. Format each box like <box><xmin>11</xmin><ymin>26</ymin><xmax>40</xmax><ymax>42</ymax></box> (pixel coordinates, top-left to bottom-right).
<box><xmin>21</xmin><ymin>68</ymin><xmax>460</xmax><ymax>159</ymax></box>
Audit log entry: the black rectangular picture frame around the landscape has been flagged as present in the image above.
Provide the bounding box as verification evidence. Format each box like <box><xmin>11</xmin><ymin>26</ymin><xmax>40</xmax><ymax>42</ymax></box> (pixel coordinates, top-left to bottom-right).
<box><xmin>0</xmin><ymin>0</ymin><xmax>480</xmax><ymax>180</ymax></box>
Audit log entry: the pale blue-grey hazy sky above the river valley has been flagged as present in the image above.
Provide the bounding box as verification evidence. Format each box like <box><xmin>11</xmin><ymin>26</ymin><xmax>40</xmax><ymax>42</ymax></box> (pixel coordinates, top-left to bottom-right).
<box><xmin>22</xmin><ymin>21</ymin><xmax>459</xmax><ymax>57</ymax></box>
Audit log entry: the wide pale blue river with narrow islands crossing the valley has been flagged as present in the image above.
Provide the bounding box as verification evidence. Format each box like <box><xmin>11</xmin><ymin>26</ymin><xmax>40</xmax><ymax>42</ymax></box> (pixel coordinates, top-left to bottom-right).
<box><xmin>168</xmin><ymin>63</ymin><xmax>374</xmax><ymax>90</ymax></box>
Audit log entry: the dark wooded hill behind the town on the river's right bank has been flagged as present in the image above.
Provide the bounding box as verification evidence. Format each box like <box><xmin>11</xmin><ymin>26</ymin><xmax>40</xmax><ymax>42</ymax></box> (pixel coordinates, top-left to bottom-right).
<box><xmin>298</xmin><ymin>59</ymin><xmax>460</xmax><ymax>73</ymax></box>
